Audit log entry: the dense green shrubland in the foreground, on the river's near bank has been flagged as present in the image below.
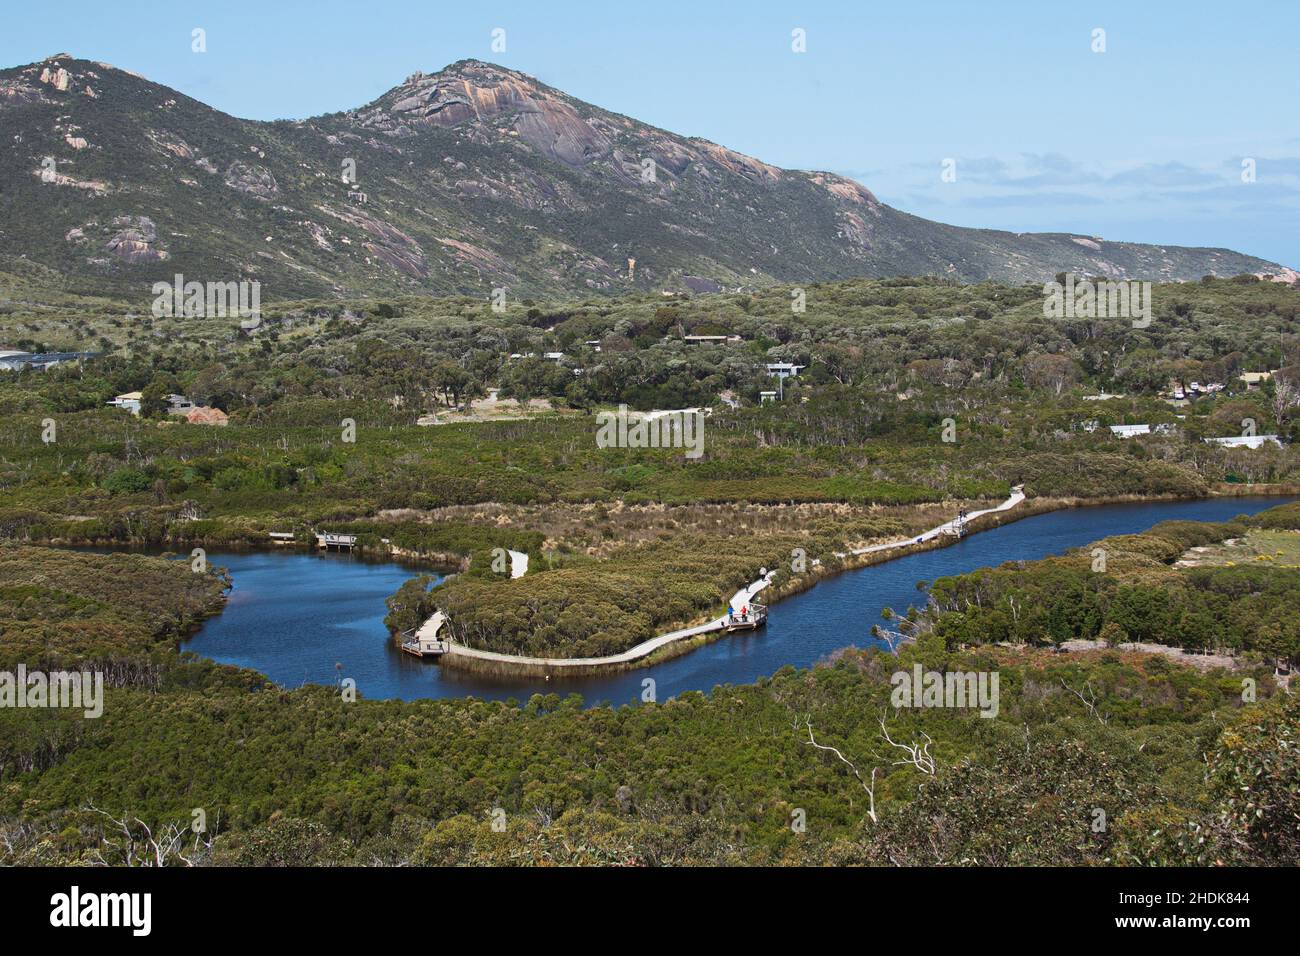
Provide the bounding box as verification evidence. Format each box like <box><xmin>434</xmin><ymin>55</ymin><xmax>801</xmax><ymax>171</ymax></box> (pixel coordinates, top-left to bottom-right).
<box><xmin>0</xmin><ymin>506</ymin><xmax>1300</xmax><ymax>865</ymax></box>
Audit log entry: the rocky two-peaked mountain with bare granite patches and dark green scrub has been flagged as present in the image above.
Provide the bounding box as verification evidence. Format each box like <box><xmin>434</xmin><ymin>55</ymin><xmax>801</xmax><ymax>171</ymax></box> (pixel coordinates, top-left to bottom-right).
<box><xmin>0</xmin><ymin>55</ymin><xmax>1283</xmax><ymax>299</ymax></box>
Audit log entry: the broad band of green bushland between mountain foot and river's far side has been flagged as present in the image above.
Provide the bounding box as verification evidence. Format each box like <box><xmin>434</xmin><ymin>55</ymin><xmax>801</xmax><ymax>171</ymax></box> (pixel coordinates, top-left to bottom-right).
<box><xmin>0</xmin><ymin>278</ymin><xmax>1300</xmax><ymax>554</ymax></box>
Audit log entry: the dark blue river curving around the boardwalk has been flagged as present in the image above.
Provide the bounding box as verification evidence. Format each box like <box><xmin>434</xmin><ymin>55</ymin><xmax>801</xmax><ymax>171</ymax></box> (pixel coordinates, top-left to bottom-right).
<box><xmin>186</xmin><ymin>497</ymin><xmax>1290</xmax><ymax>705</ymax></box>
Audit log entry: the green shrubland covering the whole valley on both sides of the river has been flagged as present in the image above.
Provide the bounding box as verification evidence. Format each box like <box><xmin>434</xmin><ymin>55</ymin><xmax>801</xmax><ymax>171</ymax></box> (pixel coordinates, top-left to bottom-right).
<box><xmin>0</xmin><ymin>280</ymin><xmax>1300</xmax><ymax>865</ymax></box>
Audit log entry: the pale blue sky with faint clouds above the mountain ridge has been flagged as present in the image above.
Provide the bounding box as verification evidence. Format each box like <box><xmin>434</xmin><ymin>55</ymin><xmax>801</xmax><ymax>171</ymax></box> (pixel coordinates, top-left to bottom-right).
<box><xmin>10</xmin><ymin>0</ymin><xmax>1300</xmax><ymax>268</ymax></box>
